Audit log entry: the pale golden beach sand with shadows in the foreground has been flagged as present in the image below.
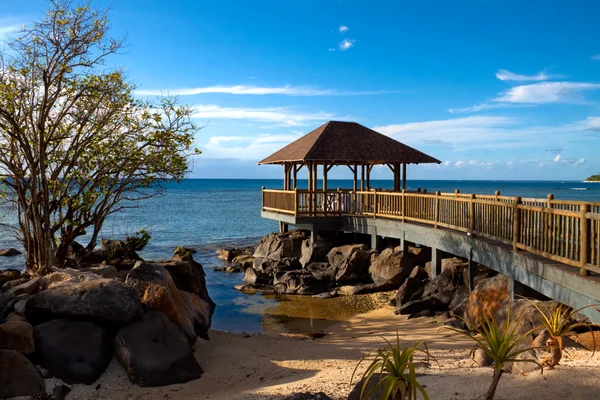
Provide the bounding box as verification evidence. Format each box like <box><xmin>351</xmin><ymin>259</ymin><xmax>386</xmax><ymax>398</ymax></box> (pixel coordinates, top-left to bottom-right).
<box><xmin>47</xmin><ymin>307</ymin><xmax>600</xmax><ymax>400</ymax></box>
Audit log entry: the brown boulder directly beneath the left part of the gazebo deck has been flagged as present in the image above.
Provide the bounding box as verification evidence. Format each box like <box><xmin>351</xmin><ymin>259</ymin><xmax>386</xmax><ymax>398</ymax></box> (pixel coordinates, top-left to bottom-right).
<box><xmin>253</xmin><ymin>229</ymin><xmax>310</xmax><ymax>261</ymax></box>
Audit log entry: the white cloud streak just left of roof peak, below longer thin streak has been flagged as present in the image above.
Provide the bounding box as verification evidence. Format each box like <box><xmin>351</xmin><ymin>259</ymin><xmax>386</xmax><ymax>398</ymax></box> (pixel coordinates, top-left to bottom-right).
<box><xmin>192</xmin><ymin>105</ymin><xmax>334</xmax><ymax>126</ymax></box>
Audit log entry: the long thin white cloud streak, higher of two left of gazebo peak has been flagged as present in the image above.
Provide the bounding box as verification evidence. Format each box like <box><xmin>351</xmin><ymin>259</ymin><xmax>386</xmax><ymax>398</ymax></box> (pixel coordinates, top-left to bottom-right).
<box><xmin>135</xmin><ymin>85</ymin><xmax>387</xmax><ymax>96</ymax></box>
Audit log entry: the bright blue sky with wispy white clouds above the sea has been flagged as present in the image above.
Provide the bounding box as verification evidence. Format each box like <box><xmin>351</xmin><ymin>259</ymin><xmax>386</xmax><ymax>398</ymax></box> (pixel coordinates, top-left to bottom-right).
<box><xmin>0</xmin><ymin>0</ymin><xmax>600</xmax><ymax>180</ymax></box>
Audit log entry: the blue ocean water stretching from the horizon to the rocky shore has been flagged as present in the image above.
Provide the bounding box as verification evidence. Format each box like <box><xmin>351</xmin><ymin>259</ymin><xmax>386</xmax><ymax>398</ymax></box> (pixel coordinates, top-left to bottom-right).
<box><xmin>0</xmin><ymin>179</ymin><xmax>600</xmax><ymax>333</ymax></box>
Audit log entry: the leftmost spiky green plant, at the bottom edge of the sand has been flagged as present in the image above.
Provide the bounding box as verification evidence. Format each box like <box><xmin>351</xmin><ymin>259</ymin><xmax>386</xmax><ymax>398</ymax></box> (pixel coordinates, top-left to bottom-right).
<box><xmin>350</xmin><ymin>333</ymin><xmax>433</xmax><ymax>400</ymax></box>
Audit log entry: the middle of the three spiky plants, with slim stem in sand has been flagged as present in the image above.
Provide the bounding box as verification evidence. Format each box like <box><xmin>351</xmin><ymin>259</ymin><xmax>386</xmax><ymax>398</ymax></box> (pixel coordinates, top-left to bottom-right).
<box><xmin>446</xmin><ymin>307</ymin><xmax>545</xmax><ymax>400</ymax></box>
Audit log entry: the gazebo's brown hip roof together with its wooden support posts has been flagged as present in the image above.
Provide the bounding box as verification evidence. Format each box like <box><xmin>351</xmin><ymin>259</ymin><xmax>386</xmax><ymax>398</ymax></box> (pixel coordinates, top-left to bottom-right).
<box><xmin>258</xmin><ymin>121</ymin><xmax>440</xmax><ymax>192</ymax></box>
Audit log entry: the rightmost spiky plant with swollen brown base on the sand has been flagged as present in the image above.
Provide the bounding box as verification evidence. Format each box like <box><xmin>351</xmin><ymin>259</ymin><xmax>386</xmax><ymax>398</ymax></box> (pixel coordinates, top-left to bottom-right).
<box><xmin>526</xmin><ymin>299</ymin><xmax>598</xmax><ymax>368</ymax></box>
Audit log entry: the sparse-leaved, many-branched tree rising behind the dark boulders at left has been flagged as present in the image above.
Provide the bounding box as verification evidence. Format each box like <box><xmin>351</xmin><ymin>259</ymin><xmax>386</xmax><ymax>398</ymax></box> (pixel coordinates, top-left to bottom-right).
<box><xmin>0</xmin><ymin>0</ymin><xmax>202</xmax><ymax>273</ymax></box>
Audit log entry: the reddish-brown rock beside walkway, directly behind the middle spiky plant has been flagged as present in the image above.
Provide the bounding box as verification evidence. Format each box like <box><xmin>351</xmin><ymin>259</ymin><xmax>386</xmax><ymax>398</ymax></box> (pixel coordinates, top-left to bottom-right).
<box><xmin>465</xmin><ymin>275</ymin><xmax>510</xmax><ymax>328</ymax></box>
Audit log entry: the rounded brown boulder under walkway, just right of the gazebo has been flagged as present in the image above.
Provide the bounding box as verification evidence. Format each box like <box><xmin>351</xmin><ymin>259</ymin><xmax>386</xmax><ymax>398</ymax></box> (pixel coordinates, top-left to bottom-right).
<box><xmin>369</xmin><ymin>247</ymin><xmax>412</xmax><ymax>287</ymax></box>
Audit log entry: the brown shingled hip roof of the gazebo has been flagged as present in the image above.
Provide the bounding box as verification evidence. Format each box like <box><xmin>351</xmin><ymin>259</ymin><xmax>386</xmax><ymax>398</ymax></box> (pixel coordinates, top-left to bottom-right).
<box><xmin>258</xmin><ymin>121</ymin><xmax>441</xmax><ymax>165</ymax></box>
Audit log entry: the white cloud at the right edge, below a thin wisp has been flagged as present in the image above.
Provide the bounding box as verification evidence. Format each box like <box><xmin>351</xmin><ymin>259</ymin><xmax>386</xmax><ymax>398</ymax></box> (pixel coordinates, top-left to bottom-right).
<box><xmin>493</xmin><ymin>82</ymin><xmax>600</xmax><ymax>104</ymax></box>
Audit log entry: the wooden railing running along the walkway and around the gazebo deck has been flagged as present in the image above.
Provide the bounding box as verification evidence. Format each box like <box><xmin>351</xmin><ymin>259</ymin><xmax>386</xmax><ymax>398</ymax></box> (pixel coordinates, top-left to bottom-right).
<box><xmin>262</xmin><ymin>189</ymin><xmax>600</xmax><ymax>275</ymax></box>
